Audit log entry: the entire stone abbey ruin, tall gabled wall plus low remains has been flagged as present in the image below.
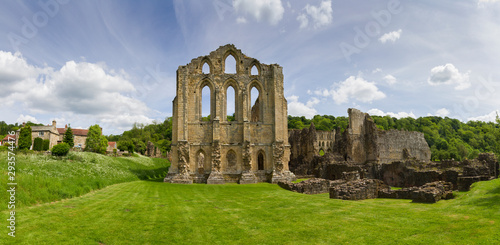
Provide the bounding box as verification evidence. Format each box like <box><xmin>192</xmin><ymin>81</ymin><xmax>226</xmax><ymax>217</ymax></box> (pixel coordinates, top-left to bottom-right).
<box><xmin>164</xmin><ymin>45</ymin><xmax>498</xmax><ymax>195</ymax></box>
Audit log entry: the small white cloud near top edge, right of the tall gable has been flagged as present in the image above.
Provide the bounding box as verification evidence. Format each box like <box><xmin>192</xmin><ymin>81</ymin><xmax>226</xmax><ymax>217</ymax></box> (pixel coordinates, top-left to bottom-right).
<box><xmin>297</xmin><ymin>0</ymin><xmax>333</xmax><ymax>28</ymax></box>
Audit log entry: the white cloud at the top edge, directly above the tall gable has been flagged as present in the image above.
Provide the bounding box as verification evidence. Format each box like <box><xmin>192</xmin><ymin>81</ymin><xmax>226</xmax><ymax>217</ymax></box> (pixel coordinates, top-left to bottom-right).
<box><xmin>233</xmin><ymin>0</ymin><xmax>285</xmax><ymax>25</ymax></box>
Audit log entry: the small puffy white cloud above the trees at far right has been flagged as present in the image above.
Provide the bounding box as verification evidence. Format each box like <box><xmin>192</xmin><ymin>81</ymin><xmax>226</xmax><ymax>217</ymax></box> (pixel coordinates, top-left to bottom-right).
<box><xmin>427</xmin><ymin>64</ymin><xmax>471</xmax><ymax>90</ymax></box>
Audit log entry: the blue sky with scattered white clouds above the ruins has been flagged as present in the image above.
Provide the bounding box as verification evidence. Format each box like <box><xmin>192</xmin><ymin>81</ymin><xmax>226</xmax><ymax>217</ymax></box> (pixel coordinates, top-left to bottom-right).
<box><xmin>0</xmin><ymin>0</ymin><xmax>500</xmax><ymax>134</ymax></box>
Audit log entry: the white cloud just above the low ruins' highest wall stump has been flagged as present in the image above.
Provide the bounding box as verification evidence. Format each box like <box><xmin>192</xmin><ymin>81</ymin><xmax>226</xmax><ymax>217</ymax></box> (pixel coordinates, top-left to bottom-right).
<box><xmin>314</xmin><ymin>76</ymin><xmax>386</xmax><ymax>104</ymax></box>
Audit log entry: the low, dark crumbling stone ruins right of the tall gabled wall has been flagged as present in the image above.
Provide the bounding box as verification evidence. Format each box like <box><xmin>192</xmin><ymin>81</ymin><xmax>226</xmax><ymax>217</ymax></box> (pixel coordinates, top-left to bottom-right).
<box><xmin>279</xmin><ymin>109</ymin><xmax>499</xmax><ymax>203</ymax></box>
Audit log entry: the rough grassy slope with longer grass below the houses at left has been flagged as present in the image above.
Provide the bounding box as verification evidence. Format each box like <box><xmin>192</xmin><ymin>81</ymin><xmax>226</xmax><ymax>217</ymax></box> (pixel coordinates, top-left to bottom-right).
<box><xmin>0</xmin><ymin>152</ymin><xmax>168</xmax><ymax>211</ymax></box>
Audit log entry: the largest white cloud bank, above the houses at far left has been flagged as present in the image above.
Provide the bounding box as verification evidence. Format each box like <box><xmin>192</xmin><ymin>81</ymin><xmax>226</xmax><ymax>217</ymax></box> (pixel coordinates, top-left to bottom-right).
<box><xmin>0</xmin><ymin>51</ymin><xmax>152</xmax><ymax>133</ymax></box>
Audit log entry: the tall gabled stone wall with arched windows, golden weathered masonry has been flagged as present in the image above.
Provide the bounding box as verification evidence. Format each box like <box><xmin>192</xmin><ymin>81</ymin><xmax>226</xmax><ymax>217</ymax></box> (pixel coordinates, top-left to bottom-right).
<box><xmin>165</xmin><ymin>45</ymin><xmax>295</xmax><ymax>184</ymax></box>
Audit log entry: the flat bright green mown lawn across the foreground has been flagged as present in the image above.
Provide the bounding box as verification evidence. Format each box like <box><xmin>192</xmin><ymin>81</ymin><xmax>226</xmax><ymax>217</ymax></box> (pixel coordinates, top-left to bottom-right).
<box><xmin>0</xmin><ymin>180</ymin><xmax>500</xmax><ymax>244</ymax></box>
